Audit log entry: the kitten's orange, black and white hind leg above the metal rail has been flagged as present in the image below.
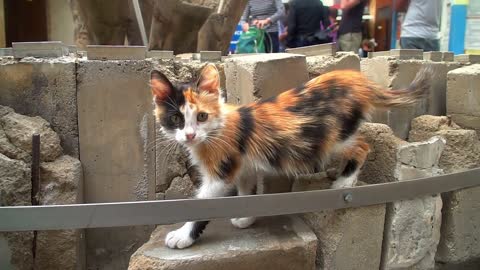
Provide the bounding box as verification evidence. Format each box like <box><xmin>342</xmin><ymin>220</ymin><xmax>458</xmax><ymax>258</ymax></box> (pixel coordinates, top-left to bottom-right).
<box><xmin>332</xmin><ymin>137</ymin><xmax>370</xmax><ymax>188</ymax></box>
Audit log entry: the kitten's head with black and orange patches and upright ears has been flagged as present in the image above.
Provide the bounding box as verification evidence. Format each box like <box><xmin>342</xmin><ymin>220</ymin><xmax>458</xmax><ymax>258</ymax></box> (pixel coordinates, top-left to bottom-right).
<box><xmin>150</xmin><ymin>64</ymin><xmax>223</xmax><ymax>146</ymax></box>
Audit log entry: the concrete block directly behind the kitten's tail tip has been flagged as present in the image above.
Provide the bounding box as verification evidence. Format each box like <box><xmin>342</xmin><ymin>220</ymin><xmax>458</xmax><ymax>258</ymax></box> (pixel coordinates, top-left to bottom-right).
<box><xmin>361</xmin><ymin>57</ymin><xmax>460</xmax><ymax>139</ymax></box>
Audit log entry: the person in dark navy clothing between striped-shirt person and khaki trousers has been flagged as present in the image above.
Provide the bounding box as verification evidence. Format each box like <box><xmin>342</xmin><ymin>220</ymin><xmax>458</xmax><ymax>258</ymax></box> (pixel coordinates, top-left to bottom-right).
<box><xmin>287</xmin><ymin>0</ymin><xmax>330</xmax><ymax>48</ymax></box>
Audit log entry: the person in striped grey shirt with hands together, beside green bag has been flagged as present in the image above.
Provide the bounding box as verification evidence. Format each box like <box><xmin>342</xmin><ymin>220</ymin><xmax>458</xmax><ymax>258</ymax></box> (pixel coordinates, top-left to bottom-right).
<box><xmin>240</xmin><ymin>0</ymin><xmax>285</xmax><ymax>53</ymax></box>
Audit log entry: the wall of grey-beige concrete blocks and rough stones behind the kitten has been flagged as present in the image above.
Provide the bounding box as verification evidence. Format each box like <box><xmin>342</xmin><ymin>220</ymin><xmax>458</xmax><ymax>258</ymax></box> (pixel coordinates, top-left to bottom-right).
<box><xmin>0</xmin><ymin>49</ymin><xmax>480</xmax><ymax>269</ymax></box>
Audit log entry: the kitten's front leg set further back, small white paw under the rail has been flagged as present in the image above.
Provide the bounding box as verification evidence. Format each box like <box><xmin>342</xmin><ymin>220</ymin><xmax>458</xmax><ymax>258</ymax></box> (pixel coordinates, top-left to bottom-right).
<box><xmin>230</xmin><ymin>172</ymin><xmax>262</xmax><ymax>229</ymax></box>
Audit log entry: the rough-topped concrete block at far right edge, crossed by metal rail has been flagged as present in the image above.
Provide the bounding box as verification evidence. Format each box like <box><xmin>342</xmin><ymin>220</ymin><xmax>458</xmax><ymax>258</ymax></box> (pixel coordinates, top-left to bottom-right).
<box><xmin>410</xmin><ymin>115</ymin><xmax>480</xmax><ymax>269</ymax></box>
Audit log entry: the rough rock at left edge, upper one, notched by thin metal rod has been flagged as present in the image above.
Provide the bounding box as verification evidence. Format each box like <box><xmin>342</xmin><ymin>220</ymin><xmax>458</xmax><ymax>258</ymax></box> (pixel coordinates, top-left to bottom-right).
<box><xmin>0</xmin><ymin>105</ymin><xmax>63</xmax><ymax>161</ymax></box>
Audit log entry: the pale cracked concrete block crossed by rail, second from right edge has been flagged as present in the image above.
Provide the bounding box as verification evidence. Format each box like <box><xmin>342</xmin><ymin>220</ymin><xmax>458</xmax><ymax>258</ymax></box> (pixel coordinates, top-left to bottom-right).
<box><xmin>381</xmin><ymin>137</ymin><xmax>445</xmax><ymax>270</ymax></box>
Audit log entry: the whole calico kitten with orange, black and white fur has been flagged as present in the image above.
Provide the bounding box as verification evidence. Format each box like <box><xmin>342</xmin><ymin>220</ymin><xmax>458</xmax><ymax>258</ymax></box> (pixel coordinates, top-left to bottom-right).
<box><xmin>150</xmin><ymin>65</ymin><xmax>430</xmax><ymax>249</ymax></box>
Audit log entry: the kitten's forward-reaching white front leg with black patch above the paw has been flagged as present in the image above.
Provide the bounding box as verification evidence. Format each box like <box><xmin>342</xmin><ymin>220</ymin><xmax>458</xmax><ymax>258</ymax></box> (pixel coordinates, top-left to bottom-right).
<box><xmin>165</xmin><ymin>179</ymin><xmax>233</xmax><ymax>249</ymax></box>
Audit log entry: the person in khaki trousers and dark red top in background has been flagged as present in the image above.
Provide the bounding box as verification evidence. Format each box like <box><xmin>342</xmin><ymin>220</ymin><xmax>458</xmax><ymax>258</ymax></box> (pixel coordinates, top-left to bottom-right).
<box><xmin>338</xmin><ymin>0</ymin><xmax>367</xmax><ymax>53</ymax></box>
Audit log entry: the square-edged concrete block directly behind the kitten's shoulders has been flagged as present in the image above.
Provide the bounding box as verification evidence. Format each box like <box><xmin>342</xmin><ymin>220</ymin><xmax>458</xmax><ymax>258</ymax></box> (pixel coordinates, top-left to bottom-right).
<box><xmin>225</xmin><ymin>53</ymin><xmax>308</xmax><ymax>104</ymax></box>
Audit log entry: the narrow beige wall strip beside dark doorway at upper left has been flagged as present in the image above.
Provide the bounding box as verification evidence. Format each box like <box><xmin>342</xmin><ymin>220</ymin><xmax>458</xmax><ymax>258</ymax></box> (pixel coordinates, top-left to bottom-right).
<box><xmin>46</xmin><ymin>0</ymin><xmax>75</xmax><ymax>45</ymax></box>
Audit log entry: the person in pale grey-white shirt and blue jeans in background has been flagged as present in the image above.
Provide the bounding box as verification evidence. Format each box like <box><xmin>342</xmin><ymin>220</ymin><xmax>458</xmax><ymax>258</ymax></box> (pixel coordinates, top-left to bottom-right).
<box><xmin>395</xmin><ymin>0</ymin><xmax>442</xmax><ymax>52</ymax></box>
